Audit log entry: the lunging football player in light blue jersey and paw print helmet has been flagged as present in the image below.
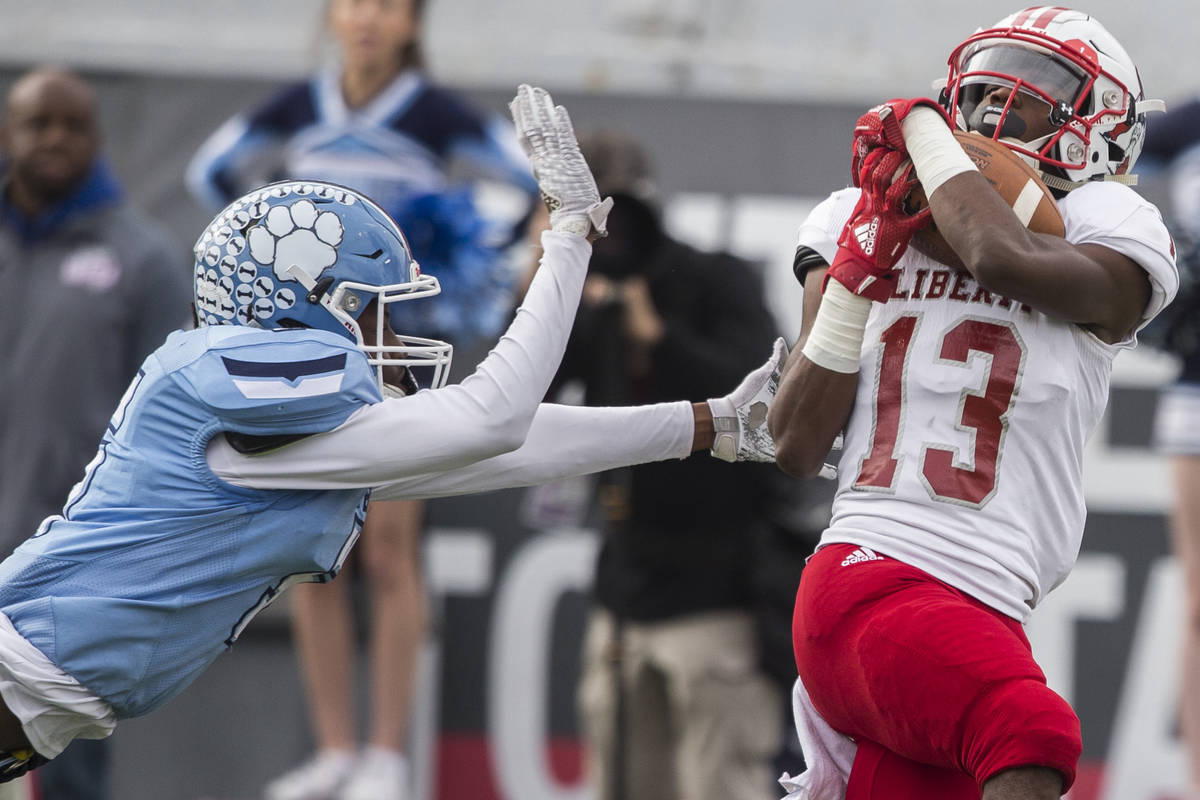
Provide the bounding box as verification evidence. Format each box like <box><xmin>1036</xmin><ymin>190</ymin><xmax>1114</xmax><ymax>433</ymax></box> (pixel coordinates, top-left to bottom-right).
<box><xmin>0</xmin><ymin>86</ymin><xmax>785</xmax><ymax>780</ymax></box>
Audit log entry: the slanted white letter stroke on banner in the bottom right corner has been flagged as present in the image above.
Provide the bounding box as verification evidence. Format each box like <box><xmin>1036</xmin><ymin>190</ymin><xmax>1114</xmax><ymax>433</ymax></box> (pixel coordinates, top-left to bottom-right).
<box><xmin>1100</xmin><ymin>558</ymin><xmax>1187</xmax><ymax>800</ymax></box>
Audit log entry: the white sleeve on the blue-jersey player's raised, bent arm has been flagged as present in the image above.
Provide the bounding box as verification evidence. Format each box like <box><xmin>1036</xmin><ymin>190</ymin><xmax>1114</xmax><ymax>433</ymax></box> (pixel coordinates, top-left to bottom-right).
<box><xmin>206</xmin><ymin>231</ymin><xmax>592</xmax><ymax>488</ymax></box>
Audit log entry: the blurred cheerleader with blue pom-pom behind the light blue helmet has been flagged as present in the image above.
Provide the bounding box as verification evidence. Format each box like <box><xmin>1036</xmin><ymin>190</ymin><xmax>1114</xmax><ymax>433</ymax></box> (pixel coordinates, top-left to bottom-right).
<box><xmin>188</xmin><ymin>0</ymin><xmax>537</xmax><ymax>800</ymax></box>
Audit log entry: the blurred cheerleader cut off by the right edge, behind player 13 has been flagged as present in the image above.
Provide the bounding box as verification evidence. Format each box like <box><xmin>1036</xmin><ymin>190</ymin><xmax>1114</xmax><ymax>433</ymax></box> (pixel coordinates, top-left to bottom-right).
<box><xmin>1144</xmin><ymin>100</ymin><xmax>1200</xmax><ymax>796</ymax></box>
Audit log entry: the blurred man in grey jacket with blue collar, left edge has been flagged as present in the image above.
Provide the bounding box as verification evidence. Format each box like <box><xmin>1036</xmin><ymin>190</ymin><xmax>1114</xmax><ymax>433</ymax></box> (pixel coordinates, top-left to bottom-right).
<box><xmin>0</xmin><ymin>67</ymin><xmax>191</xmax><ymax>800</ymax></box>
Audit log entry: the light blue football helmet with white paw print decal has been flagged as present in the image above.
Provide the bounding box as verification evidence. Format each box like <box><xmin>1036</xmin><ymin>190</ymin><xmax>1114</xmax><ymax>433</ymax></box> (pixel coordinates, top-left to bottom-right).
<box><xmin>194</xmin><ymin>181</ymin><xmax>452</xmax><ymax>387</ymax></box>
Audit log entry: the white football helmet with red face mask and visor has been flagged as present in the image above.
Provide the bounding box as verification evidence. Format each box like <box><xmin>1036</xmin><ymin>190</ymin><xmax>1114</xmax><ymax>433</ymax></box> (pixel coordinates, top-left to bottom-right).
<box><xmin>942</xmin><ymin>6</ymin><xmax>1165</xmax><ymax>191</ymax></box>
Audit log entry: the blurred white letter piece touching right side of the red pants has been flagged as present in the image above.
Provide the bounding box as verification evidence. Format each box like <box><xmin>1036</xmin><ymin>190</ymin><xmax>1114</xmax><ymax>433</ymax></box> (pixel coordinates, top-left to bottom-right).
<box><xmin>1025</xmin><ymin>553</ymin><xmax>1127</xmax><ymax>705</ymax></box>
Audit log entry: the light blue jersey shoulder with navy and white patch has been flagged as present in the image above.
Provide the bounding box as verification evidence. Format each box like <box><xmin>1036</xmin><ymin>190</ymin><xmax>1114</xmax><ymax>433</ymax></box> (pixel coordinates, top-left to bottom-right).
<box><xmin>175</xmin><ymin>329</ymin><xmax>380</xmax><ymax>437</ymax></box>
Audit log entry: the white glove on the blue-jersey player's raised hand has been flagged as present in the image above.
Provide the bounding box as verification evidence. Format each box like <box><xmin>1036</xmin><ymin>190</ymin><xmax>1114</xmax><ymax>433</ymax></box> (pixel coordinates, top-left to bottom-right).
<box><xmin>509</xmin><ymin>84</ymin><xmax>612</xmax><ymax>236</ymax></box>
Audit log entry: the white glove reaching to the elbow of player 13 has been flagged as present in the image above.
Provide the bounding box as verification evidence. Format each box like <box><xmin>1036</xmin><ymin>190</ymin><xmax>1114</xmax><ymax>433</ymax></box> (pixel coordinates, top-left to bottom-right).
<box><xmin>708</xmin><ymin>338</ymin><xmax>787</xmax><ymax>462</ymax></box>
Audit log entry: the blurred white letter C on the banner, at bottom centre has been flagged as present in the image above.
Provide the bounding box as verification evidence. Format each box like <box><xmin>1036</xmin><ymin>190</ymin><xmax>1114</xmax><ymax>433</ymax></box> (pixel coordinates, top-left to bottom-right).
<box><xmin>487</xmin><ymin>529</ymin><xmax>599</xmax><ymax>800</ymax></box>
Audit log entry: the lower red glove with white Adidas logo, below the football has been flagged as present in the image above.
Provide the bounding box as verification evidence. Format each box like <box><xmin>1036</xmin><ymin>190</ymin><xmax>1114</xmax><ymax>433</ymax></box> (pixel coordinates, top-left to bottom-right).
<box><xmin>822</xmin><ymin>148</ymin><xmax>930</xmax><ymax>302</ymax></box>
